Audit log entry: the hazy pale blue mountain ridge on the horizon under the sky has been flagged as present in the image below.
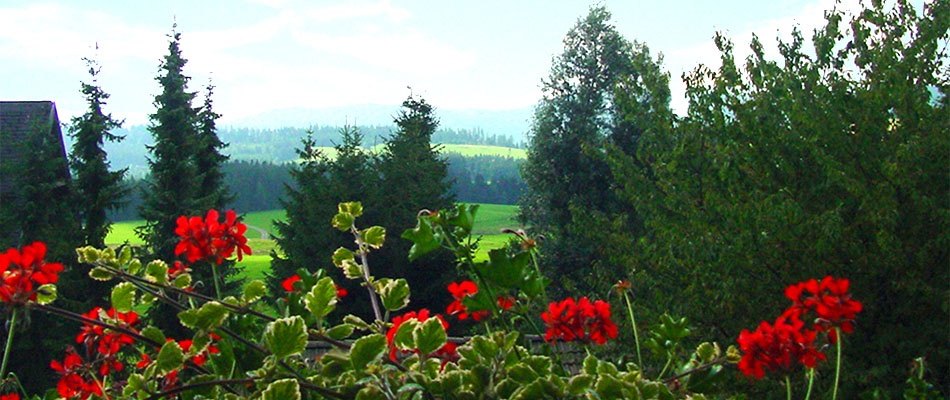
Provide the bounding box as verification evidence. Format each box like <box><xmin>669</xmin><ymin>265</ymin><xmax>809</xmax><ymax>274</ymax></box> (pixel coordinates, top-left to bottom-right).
<box><xmin>220</xmin><ymin>104</ymin><xmax>533</xmax><ymax>142</ymax></box>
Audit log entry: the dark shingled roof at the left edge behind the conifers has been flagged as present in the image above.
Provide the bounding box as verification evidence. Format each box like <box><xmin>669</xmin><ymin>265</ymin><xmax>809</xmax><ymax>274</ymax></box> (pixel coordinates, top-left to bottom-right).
<box><xmin>0</xmin><ymin>101</ymin><xmax>69</xmax><ymax>198</ymax></box>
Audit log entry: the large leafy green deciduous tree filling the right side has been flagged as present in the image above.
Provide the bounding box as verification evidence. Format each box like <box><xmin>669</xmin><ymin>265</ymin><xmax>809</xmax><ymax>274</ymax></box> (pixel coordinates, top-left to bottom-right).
<box><xmin>610</xmin><ymin>1</ymin><xmax>950</xmax><ymax>398</ymax></box>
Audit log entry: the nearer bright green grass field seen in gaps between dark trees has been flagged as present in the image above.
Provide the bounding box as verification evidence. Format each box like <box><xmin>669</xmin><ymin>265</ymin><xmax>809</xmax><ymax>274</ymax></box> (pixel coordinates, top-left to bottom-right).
<box><xmin>106</xmin><ymin>204</ymin><xmax>520</xmax><ymax>280</ymax></box>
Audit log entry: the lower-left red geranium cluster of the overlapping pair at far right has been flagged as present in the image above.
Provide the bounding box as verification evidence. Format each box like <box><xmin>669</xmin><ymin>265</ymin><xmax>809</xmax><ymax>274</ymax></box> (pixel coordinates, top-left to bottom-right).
<box><xmin>739</xmin><ymin>316</ymin><xmax>825</xmax><ymax>379</ymax></box>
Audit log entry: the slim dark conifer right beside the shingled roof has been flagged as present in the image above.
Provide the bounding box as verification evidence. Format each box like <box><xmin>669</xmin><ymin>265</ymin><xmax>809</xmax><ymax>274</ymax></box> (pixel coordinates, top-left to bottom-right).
<box><xmin>69</xmin><ymin>54</ymin><xmax>128</xmax><ymax>248</ymax></box>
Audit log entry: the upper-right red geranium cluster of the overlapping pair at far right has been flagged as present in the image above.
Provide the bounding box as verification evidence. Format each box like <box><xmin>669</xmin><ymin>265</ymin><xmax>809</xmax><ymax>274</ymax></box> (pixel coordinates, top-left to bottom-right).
<box><xmin>784</xmin><ymin>276</ymin><xmax>861</xmax><ymax>343</ymax></box>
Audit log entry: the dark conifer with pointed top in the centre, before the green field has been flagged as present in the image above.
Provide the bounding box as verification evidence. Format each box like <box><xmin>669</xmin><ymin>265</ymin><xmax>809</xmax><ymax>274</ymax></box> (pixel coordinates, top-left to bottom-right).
<box><xmin>376</xmin><ymin>95</ymin><xmax>457</xmax><ymax>310</ymax></box>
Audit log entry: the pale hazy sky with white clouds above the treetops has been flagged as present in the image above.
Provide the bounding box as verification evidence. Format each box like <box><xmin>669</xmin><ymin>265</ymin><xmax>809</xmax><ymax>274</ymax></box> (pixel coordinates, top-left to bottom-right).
<box><xmin>0</xmin><ymin>0</ymin><xmax>919</xmax><ymax>124</ymax></box>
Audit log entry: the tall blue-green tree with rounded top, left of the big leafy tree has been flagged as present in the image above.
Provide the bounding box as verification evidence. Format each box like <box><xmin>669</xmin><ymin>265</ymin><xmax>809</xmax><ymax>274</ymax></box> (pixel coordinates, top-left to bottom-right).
<box><xmin>521</xmin><ymin>6</ymin><xmax>669</xmax><ymax>292</ymax></box>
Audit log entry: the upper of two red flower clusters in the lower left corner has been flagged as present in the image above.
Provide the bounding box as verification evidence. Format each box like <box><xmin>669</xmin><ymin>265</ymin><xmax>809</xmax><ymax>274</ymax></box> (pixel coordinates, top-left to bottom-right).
<box><xmin>76</xmin><ymin>307</ymin><xmax>139</xmax><ymax>376</ymax></box>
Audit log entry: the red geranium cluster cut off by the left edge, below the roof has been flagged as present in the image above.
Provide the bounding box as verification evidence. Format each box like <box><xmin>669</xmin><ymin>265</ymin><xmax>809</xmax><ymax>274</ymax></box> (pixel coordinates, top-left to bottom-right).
<box><xmin>0</xmin><ymin>242</ymin><xmax>63</xmax><ymax>304</ymax></box>
